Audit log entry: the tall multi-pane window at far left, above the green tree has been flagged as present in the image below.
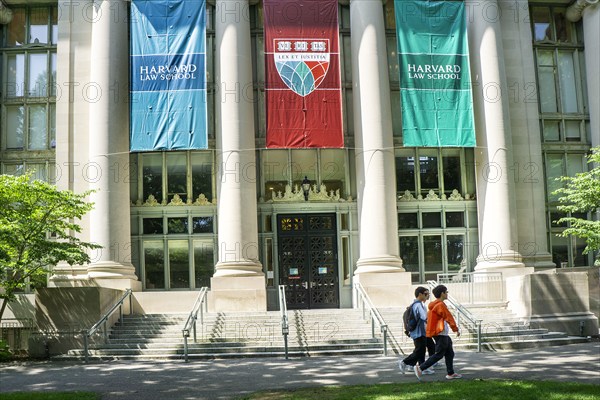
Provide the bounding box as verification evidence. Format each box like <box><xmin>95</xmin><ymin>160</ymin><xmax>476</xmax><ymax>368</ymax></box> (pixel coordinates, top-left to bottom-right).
<box><xmin>0</xmin><ymin>6</ymin><xmax>58</xmax><ymax>180</ymax></box>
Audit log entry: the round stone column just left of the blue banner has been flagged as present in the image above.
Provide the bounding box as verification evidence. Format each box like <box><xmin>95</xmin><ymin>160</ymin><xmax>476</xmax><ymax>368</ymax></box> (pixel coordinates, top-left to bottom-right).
<box><xmin>84</xmin><ymin>0</ymin><xmax>141</xmax><ymax>289</ymax></box>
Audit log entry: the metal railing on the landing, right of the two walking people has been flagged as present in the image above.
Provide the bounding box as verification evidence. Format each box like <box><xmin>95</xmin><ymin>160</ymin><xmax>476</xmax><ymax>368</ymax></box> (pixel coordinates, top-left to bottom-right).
<box><xmin>437</xmin><ymin>272</ymin><xmax>504</xmax><ymax>304</ymax></box>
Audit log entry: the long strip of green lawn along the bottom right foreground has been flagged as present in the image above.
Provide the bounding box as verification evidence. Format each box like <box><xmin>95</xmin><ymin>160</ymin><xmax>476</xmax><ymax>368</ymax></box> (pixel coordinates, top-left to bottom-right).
<box><xmin>242</xmin><ymin>379</ymin><xmax>600</xmax><ymax>400</ymax></box>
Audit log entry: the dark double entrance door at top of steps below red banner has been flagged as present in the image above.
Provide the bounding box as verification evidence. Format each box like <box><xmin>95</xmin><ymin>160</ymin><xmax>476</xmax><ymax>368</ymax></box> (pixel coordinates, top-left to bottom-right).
<box><xmin>277</xmin><ymin>214</ymin><xmax>340</xmax><ymax>309</ymax></box>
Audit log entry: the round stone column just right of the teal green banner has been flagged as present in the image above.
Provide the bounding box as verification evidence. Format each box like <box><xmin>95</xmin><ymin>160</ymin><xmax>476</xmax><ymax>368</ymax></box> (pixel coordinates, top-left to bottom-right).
<box><xmin>465</xmin><ymin>0</ymin><xmax>533</xmax><ymax>278</ymax></box>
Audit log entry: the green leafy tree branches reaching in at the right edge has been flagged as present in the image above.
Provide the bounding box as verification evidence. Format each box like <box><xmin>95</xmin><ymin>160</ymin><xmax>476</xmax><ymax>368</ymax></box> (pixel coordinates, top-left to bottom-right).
<box><xmin>554</xmin><ymin>147</ymin><xmax>600</xmax><ymax>265</ymax></box>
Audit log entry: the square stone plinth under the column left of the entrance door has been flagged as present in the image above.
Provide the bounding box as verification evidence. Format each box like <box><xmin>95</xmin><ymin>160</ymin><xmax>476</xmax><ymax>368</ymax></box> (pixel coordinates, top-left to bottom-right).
<box><xmin>208</xmin><ymin>274</ymin><xmax>267</xmax><ymax>312</ymax></box>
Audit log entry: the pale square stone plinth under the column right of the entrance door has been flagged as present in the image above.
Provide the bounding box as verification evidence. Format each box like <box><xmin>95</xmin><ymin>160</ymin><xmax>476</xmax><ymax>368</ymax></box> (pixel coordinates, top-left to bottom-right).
<box><xmin>354</xmin><ymin>268</ymin><xmax>415</xmax><ymax>307</ymax></box>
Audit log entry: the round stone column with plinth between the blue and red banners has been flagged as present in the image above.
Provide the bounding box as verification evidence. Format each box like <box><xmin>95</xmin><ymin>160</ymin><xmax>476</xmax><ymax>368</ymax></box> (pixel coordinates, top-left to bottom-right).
<box><xmin>209</xmin><ymin>0</ymin><xmax>266</xmax><ymax>311</ymax></box>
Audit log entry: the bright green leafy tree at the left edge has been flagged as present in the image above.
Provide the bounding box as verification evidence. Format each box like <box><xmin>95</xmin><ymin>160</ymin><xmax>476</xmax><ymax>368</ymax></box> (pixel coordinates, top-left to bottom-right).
<box><xmin>0</xmin><ymin>173</ymin><xmax>100</xmax><ymax>320</ymax></box>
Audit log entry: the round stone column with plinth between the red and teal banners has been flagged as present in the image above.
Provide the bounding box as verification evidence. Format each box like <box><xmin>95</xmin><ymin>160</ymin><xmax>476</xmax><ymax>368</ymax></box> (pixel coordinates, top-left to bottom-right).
<box><xmin>350</xmin><ymin>0</ymin><xmax>411</xmax><ymax>306</ymax></box>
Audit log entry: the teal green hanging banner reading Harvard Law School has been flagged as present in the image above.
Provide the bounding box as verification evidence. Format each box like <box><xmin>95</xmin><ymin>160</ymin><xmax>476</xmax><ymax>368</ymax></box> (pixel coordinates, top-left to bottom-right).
<box><xmin>394</xmin><ymin>0</ymin><xmax>475</xmax><ymax>147</ymax></box>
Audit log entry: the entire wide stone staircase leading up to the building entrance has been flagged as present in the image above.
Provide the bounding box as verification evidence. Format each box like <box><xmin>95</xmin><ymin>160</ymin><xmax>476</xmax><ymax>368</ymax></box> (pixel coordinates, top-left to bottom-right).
<box><xmin>58</xmin><ymin>303</ymin><xmax>588</xmax><ymax>359</ymax></box>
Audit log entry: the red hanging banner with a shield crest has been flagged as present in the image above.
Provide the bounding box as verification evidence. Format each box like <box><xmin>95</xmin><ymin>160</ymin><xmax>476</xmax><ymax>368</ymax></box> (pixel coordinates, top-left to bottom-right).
<box><xmin>263</xmin><ymin>0</ymin><xmax>344</xmax><ymax>148</ymax></box>
